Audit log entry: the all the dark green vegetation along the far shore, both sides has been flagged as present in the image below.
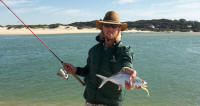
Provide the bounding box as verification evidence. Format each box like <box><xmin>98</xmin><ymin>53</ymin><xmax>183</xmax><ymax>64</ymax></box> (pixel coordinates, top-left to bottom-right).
<box><xmin>0</xmin><ymin>19</ymin><xmax>200</xmax><ymax>32</ymax></box>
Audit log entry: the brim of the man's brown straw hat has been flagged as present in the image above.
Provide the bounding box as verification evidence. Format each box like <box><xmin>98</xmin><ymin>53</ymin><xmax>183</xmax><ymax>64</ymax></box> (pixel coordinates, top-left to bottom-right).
<box><xmin>96</xmin><ymin>20</ymin><xmax>127</xmax><ymax>31</ymax></box>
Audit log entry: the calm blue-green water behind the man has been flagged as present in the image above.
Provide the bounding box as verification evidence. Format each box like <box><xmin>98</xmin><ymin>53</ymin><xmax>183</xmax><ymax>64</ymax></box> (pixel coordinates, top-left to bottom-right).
<box><xmin>0</xmin><ymin>33</ymin><xmax>200</xmax><ymax>106</ymax></box>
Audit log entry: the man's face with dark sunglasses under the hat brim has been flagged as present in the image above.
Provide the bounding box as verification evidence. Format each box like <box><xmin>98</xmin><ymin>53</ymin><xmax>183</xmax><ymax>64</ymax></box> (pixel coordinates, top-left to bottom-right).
<box><xmin>102</xmin><ymin>24</ymin><xmax>121</xmax><ymax>40</ymax></box>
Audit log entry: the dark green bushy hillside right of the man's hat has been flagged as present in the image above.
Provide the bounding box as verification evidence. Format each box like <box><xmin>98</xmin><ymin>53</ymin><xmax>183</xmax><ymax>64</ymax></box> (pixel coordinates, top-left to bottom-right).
<box><xmin>126</xmin><ymin>19</ymin><xmax>200</xmax><ymax>32</ymax></box>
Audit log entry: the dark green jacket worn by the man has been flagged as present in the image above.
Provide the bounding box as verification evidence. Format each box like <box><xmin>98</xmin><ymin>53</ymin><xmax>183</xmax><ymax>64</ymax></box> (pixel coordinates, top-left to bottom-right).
<box><xmin>76</xmin><ymin>36</ymin><xmax>133</xmax><ymax>106</ymax></box>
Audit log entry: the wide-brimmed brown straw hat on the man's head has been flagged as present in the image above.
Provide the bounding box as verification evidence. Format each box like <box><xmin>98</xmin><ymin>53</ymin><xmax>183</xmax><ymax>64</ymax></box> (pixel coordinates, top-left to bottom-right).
<box><xmin>96</xmin><ymin>11</ymin><xmax>127</xmax><ymax>31</ymax></box>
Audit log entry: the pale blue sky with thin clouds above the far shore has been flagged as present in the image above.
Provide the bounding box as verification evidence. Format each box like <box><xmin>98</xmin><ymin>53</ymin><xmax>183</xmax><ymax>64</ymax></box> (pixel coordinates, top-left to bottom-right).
<box><xmin>0</xmin><ymin>0</ymin><xmax>200</xmax><ymax>25</ymax></box>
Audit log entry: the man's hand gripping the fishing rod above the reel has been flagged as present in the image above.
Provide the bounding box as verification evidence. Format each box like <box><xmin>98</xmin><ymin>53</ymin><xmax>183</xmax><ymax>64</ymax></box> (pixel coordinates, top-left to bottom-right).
<box><xmin>62</xmin><ymin>62</ymin><xmax>76</xmax><ymax>74</ymax></box>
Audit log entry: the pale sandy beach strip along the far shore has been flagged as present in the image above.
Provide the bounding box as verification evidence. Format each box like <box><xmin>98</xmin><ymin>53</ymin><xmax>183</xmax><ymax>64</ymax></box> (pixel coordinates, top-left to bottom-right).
<box><xmin>0</xmin><ymin>26</ymin><xmax>150</xmax><ymax>35</ymax></box>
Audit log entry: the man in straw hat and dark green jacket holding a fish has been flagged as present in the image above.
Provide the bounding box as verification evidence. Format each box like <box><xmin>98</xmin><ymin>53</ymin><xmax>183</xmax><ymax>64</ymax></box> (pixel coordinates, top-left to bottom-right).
<box><xmin>63</xmin><ymin>11</ymin><xmax>136</xmax><ymax>106</ymax></box>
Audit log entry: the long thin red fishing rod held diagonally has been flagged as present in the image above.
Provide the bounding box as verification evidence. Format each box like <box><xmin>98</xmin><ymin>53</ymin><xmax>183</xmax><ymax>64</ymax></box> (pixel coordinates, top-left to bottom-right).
<box><xmin>0</xmin><ymin>0</ymin><xmax>85</xmax><ymax>85</ymax></box>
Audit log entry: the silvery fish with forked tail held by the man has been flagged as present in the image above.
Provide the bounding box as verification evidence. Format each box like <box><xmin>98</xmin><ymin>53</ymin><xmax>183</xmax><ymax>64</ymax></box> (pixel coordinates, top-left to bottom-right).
<box><xmin>96</xmin><ymin>72</ymin><xmax>150</xmax><ymax>96</ymax></box>
